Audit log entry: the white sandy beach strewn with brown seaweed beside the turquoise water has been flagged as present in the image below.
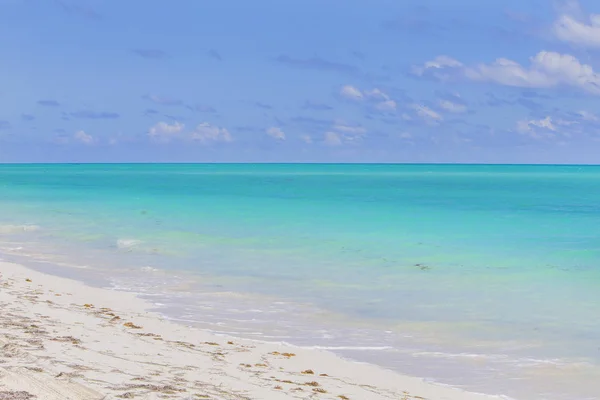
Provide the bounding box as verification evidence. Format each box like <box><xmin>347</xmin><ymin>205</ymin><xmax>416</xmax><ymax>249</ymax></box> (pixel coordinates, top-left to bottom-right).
<box><xmin>0</xmin><ymin>262</ymin><xmax>506</xmax><ymax>400</ymax></box>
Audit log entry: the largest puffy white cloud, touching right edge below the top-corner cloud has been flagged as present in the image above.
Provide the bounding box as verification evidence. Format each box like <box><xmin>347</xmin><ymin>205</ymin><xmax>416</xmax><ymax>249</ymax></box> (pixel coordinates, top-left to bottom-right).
<box><xmin>465</xmin><ymin>51</ymin><xmax>600</xmax><ymax>94</ymax></box>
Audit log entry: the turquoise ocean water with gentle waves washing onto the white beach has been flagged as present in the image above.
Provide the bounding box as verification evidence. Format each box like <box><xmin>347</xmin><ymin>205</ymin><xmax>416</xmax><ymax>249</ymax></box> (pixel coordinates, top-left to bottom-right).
<box><xmin>0</xmin><ymin>164</ymin><xmax>600</xmax><ymax>400</ymax></box>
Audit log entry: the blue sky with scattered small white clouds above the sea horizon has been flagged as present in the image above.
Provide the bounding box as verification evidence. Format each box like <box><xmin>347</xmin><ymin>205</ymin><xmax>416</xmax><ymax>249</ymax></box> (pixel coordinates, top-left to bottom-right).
<box><xmin>5</xmin><ymin>0</ymin><xmax>600</xmax><ymax>164</ymax></box>
